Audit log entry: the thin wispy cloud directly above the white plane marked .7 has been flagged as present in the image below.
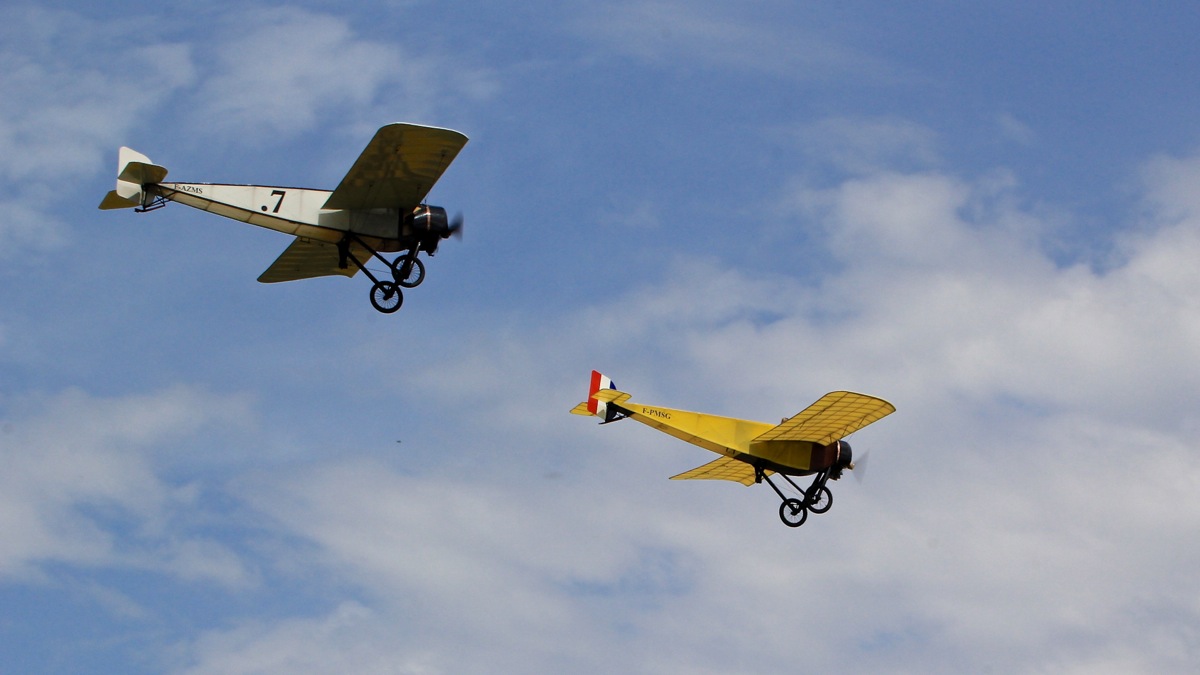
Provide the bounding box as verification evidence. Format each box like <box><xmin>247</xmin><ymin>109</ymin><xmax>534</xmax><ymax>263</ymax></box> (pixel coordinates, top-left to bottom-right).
<box><xmin>193</xmin><ymin>8</ymin><xmax>496</xmax><ymax>138</ymax></box>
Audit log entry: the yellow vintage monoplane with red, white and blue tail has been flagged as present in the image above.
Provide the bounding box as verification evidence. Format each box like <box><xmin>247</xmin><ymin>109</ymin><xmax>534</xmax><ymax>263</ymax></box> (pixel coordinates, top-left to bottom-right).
<box><xmin>571</xmin><ymin>370</ymin><xmax>896</xmax><ymax>527</ymax></box>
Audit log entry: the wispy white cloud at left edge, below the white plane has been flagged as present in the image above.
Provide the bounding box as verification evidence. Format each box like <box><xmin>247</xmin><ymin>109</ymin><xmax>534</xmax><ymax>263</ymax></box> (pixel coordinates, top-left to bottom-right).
<box><xmin>0</xmin><ymin>387</ymin><xmax>258</xmax><ymax>585</ymax></box>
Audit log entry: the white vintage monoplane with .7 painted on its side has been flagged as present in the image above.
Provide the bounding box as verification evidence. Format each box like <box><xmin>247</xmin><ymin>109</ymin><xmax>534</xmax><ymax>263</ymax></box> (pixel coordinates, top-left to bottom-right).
<box><xmin>100</xmin><ymin>124</ymin><xmax>467</xmax><ymax>312</ymax></box>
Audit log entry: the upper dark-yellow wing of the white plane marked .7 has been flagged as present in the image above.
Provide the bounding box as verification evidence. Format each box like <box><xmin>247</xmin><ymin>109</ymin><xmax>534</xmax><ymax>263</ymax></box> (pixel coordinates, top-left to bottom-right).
<box><xmin>324</xmin><ymin>124</ymin><xmax>467</xmax><ymax>211</ymax></box>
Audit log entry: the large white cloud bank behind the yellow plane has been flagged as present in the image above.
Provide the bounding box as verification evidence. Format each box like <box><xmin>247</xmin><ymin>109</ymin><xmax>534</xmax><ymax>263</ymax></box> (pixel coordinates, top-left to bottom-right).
<box><xmin>174</xmin><ymin>140</ymin><xmax>1200</xmax><ymax>673</ymax></box>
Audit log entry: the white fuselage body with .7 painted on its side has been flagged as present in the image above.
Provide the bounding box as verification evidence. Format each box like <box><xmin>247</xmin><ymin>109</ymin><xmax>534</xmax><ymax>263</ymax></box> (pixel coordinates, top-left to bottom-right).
<box><xmin>146</xmin><ymin>183</ymin><xmax>403</xmax><ymax>251</ymax></box>
